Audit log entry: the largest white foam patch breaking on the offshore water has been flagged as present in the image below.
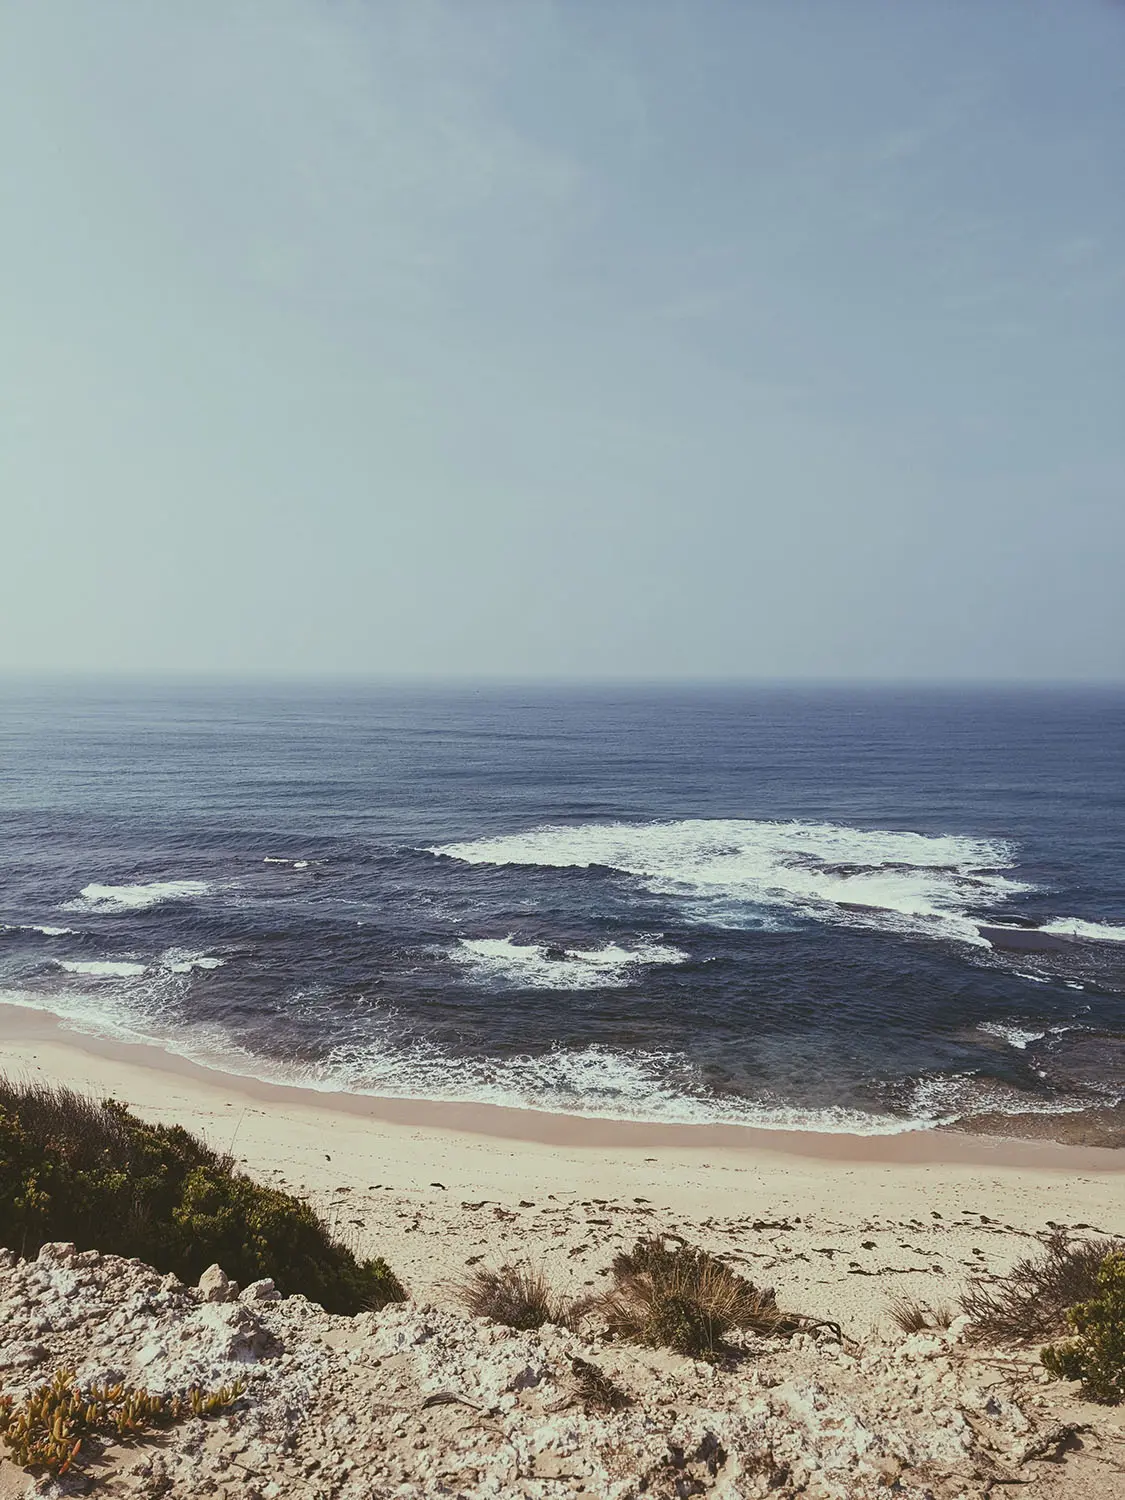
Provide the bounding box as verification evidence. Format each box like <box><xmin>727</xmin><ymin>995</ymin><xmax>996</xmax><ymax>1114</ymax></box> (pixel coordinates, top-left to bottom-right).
<box><xmin>431</xmin><ymin>819</ymin><xmax>1031</xmax><ymax>947</ymax></box>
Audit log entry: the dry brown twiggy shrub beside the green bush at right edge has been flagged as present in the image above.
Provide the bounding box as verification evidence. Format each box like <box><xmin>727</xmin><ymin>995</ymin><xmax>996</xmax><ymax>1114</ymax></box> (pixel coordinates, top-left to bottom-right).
<box><xmin>960</xmin><ymin>1230</ymin><xmax>1125</xmax><ymax>1344</ymax></box>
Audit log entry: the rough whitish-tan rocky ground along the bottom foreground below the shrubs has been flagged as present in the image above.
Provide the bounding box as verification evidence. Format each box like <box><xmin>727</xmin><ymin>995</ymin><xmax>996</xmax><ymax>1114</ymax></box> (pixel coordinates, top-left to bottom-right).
<box><xmin>0</xmin><ymin>1245</ymin><xmax>1121</xmax><ymax>1500</ymax></box>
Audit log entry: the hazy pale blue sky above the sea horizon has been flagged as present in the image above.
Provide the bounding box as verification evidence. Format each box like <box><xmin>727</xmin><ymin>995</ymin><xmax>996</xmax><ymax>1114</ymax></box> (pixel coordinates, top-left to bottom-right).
<box><xmin>0</xmin><ymin>0</ymin><xmax>1125</xmax><ymax>678</ymax></box>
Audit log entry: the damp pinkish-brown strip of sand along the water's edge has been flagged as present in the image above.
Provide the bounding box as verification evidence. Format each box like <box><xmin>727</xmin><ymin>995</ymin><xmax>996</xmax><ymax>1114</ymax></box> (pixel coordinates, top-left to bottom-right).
<box><xmin>0</xmin><ymin>1004</ymin><xmax>1125</xmax><ymax>1173</ymax></box>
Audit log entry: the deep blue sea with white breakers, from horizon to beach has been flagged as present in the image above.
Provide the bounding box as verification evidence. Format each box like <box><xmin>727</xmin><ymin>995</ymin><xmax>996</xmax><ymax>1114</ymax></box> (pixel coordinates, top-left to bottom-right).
<box><xmin>0</xmin><ymin>681</ymin><xmax>1125</xmax><ymax>1133</ymax></box>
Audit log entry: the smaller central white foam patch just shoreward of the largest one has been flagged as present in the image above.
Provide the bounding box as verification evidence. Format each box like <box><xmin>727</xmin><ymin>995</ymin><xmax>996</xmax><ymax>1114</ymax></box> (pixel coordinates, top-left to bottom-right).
<box><xmin>450</xmin><ymin>938</ymin><xmax>689</xmax><ymax>990</ymax></box>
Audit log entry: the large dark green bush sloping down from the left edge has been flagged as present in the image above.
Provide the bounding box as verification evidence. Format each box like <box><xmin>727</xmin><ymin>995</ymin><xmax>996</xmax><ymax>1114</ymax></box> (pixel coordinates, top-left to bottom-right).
<box><xmin>0</xmin><ymin>1079</ymin><xmax>405</xmax><ymax>1313</ymax></box>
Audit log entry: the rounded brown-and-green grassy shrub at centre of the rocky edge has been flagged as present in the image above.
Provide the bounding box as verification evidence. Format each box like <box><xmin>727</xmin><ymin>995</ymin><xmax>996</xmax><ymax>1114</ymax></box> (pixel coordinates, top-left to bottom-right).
<box><xmin>597</xmin><ymin>1236</ymin><xmax>815</xmax><ymax>1359</ymax></box>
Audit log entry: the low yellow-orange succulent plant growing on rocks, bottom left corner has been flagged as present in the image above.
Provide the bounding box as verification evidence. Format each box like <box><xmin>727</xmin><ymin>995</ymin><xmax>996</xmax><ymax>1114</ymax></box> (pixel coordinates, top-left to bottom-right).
<box><xmin>0</xmin><ymin>1370</ymin><xmax>246</xmax><ymax>1476</ymax></box>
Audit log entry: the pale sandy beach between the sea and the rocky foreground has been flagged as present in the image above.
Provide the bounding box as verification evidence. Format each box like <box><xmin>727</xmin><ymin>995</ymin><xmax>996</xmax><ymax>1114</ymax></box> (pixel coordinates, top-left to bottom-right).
<box><xmin>0</xmin><ymin>1007</ymin><xmax>1125</xmax><ymax>1332</ymax></box>
